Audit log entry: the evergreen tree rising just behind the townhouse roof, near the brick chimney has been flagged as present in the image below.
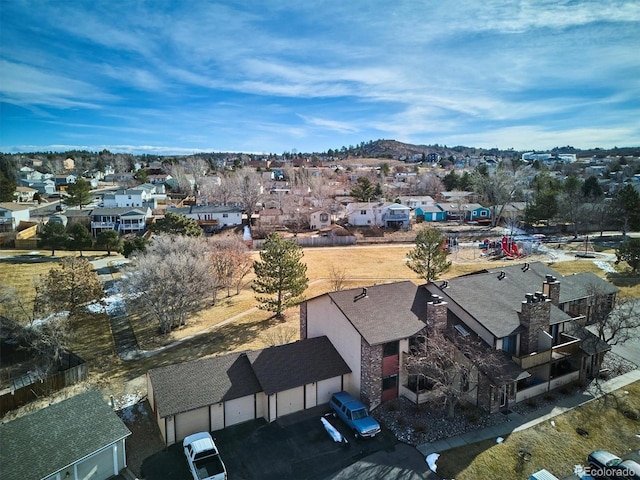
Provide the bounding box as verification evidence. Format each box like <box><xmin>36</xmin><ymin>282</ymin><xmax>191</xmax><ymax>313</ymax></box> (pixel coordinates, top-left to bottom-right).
<box><xmin>407</xmin><ymin>228</ymin><xmax>451</xmax><ymax>282</ymax></box>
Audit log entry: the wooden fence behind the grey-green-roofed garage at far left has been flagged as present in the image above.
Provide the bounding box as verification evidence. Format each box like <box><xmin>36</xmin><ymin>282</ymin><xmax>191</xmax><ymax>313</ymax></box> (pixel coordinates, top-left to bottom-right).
<box><xmin>0</xmin><ymin>352</ymin><xmax>88</xmax><ymax>416</ymax></box>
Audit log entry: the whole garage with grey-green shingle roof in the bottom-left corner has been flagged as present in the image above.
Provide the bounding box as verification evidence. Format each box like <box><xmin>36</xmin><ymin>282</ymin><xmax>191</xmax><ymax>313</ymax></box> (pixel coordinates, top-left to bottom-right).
<box><xmin>0</xmin><ymin>390</ymin><xmax>131</xmax><ymax>480</ymax></box>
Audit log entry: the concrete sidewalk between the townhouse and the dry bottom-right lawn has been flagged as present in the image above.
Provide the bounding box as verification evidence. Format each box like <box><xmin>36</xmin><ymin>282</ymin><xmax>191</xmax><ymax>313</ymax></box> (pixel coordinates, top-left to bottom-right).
<box><xmin>416</xmin><ymin>369</ymin><xmax>640</xmax><ymax>456</ymax></box>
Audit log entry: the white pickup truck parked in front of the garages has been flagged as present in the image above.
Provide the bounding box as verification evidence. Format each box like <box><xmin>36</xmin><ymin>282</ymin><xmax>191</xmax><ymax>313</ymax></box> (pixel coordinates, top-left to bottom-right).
<box><xmin>182</xmin><ymin>432</ymin><xmax>227</xmax><ymax>480</ymax></box>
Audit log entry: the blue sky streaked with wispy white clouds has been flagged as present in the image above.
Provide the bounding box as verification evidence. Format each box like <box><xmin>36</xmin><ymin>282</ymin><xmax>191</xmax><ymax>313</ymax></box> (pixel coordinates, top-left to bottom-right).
<box><xmin>0</xmin><ymin>0</ymin><xmax>640</xmax><ymax>154</ymax></box>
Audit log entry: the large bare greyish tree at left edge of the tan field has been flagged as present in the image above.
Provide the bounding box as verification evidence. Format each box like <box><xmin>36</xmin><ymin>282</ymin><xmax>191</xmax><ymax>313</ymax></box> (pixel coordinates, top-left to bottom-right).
<box><xmin>121</xmin><ymin>235</ymin><xmax>212</xmax><ymax>333</ymax></box>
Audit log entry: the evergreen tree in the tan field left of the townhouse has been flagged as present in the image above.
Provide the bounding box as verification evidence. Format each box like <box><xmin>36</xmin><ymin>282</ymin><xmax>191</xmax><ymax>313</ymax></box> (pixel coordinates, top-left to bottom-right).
<box><xmin>252</xmin><ymin>233</ymin><xmax>309</xmax><ymax>318</ymax></box>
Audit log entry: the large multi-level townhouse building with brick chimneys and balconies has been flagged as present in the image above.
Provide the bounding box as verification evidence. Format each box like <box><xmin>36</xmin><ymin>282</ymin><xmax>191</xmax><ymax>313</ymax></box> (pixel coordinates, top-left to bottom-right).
<box><xmin>300</xmin><ymin>263</ymin><xmax>617</xmax><ymax>412</ymax></box>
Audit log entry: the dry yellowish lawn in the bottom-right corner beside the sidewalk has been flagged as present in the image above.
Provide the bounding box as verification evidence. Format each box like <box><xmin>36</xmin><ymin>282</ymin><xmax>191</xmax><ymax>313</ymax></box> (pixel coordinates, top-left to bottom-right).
<box><xmin>438</xmin><ymin>382</ymin><xmax>640</xmax><ymax>480</ymax></box>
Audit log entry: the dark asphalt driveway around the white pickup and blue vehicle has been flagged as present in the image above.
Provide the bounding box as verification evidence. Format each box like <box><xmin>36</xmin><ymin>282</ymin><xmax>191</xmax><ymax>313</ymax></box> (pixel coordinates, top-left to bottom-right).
<box><xmin>142</xmin><ymin>406</ymin><xmax>438</xmax><ymax>480</ymax></box>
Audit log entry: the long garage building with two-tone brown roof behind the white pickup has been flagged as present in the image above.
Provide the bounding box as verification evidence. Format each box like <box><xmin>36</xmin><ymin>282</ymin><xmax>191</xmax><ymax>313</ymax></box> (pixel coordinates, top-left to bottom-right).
<box><xmin>147</xmin><ymin>336</ymin><xmax>351</xmax><ymax>445</ymax></box>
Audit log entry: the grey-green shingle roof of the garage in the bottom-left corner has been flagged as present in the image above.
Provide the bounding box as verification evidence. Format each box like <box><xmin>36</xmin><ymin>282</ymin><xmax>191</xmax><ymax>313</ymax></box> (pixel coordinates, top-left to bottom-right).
<box><xmin>0</xmin><ymin>390</ymin><xmax>131</xmax><ymax>480</ymax></box>
